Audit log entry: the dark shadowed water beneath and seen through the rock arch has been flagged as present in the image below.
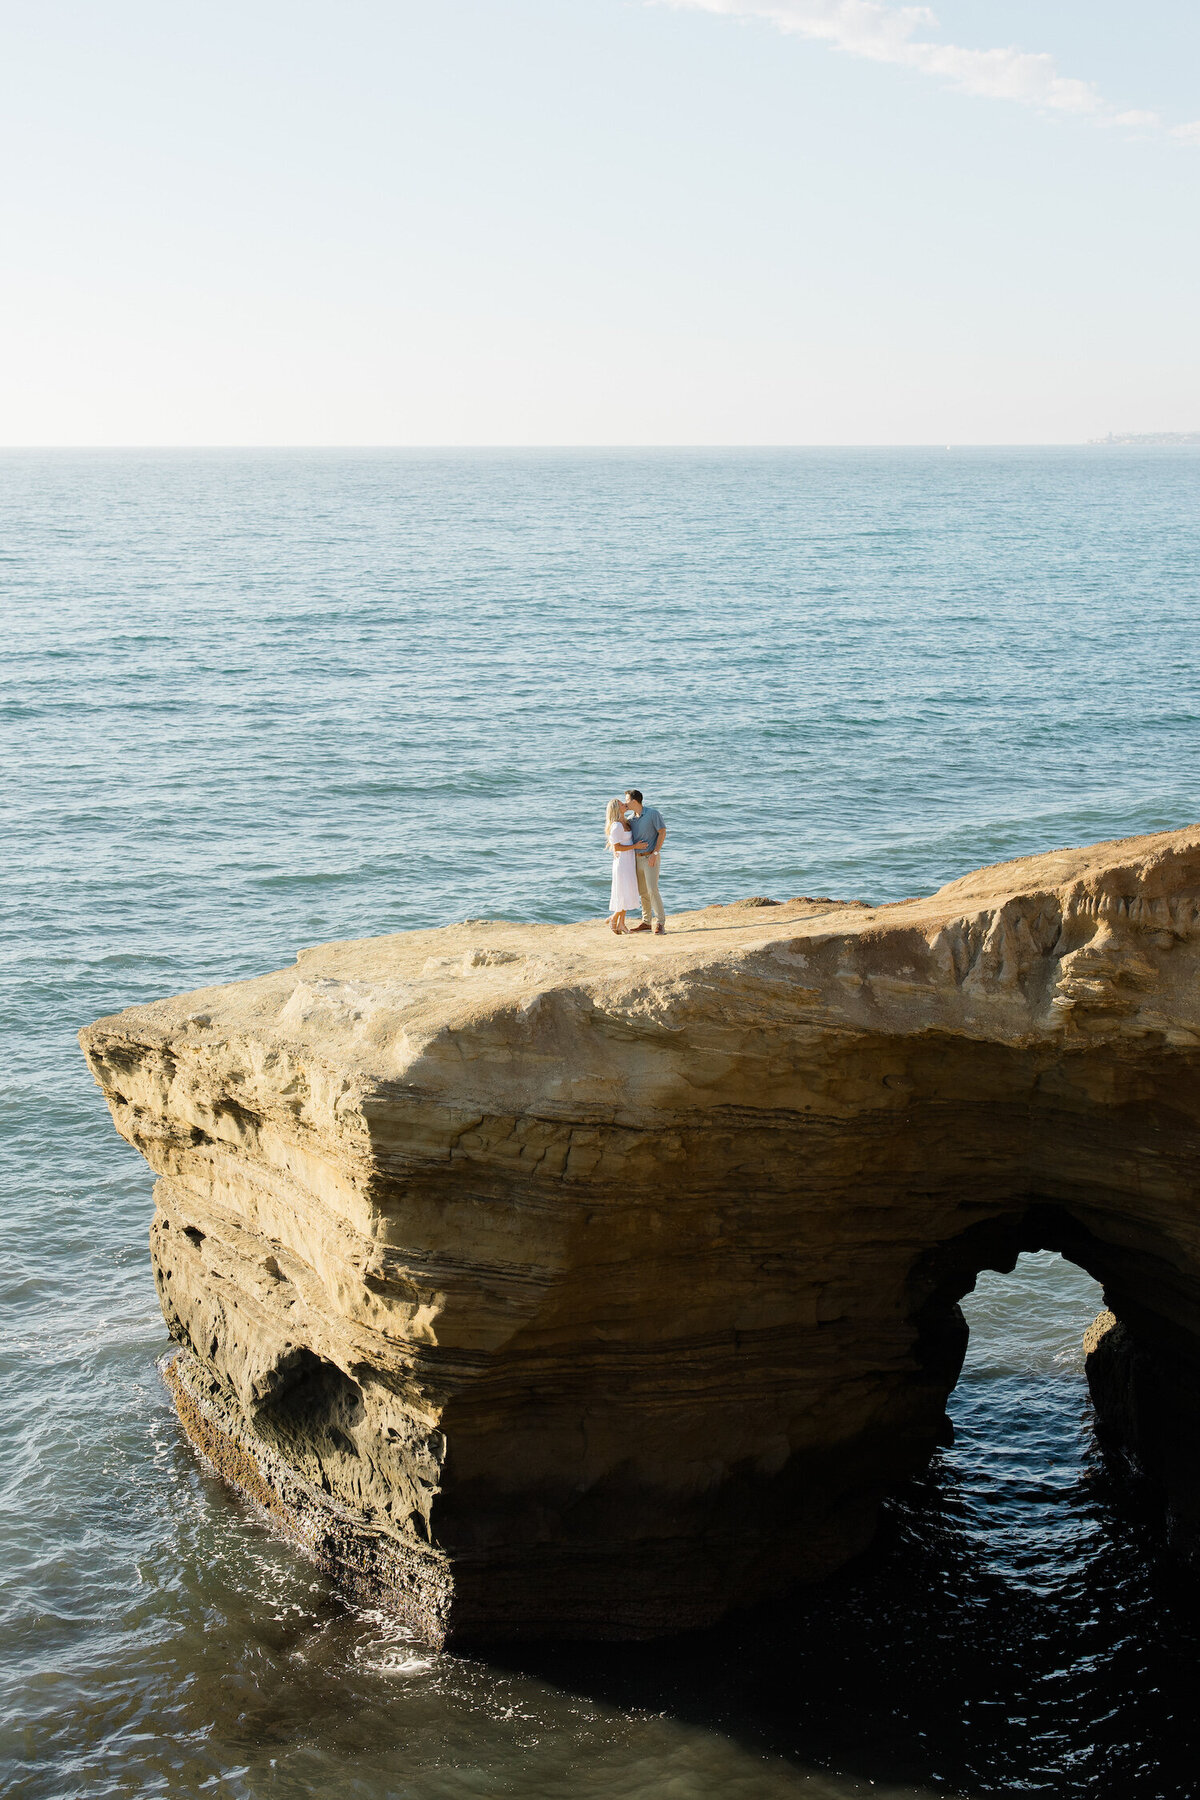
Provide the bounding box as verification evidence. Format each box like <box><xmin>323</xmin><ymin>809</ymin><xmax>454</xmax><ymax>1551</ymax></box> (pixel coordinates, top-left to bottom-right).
<box><xmin>492</xmin><ymin>1251</ymin><xmax>1200</xmax><ymax>1800</ymax></box>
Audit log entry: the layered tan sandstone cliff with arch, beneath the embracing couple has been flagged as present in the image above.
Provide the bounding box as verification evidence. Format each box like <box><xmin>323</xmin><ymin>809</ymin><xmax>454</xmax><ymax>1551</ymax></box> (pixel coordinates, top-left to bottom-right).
<box><xmin>83</xmin><ymin>828</ymin><xmax>1200</xmax><ymax>1642</ymax></box>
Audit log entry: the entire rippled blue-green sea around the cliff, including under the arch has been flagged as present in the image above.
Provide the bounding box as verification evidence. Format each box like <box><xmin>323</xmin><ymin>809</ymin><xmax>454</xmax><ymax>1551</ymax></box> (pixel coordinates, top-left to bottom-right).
<box><xmin>0</xmin><ymin>450</ymin><xmax>1200</xmax><ymax>1800</ymax></box>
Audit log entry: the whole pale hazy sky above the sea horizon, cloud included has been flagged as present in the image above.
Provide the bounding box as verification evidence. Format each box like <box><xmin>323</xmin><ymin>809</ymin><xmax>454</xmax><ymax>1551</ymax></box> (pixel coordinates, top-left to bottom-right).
<box><xmin>0</xmin><ymin>0</ymin><xmax>1200</xmax><ymax>446</ymax></box>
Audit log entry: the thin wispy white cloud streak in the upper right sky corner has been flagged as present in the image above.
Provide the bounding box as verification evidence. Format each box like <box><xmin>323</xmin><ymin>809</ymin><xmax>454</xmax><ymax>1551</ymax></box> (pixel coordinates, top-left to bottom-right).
<box><xmin>662</xmin><ymin>0</ymin><xmax>1200</xmax><ymax>144</ymax></box>
